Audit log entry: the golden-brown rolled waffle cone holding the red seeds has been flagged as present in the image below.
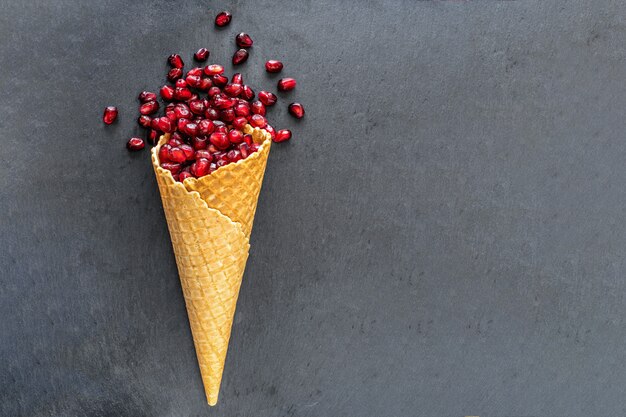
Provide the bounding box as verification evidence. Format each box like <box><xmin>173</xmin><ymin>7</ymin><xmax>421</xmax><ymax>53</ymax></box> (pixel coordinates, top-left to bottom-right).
<box><xmin>152</xmin><ymin>126</ymin><xmax>271</xmax><ymax>405</ymax></box>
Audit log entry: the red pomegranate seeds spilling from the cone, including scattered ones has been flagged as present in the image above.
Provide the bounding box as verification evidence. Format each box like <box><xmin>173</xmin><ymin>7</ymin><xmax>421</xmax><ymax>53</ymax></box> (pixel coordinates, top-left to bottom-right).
<box><xmin>103</xmin><ymin>11</ymin><xmax>304</xmax><ymax>181</ymax></box>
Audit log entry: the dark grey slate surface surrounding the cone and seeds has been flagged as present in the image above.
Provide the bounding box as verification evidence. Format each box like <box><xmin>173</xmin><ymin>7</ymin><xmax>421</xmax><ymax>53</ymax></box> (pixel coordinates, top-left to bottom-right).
<box><xmin>0</xmin><ymin>0</ymin><xmax>626</xmax><ymax>417</ymax></box>
